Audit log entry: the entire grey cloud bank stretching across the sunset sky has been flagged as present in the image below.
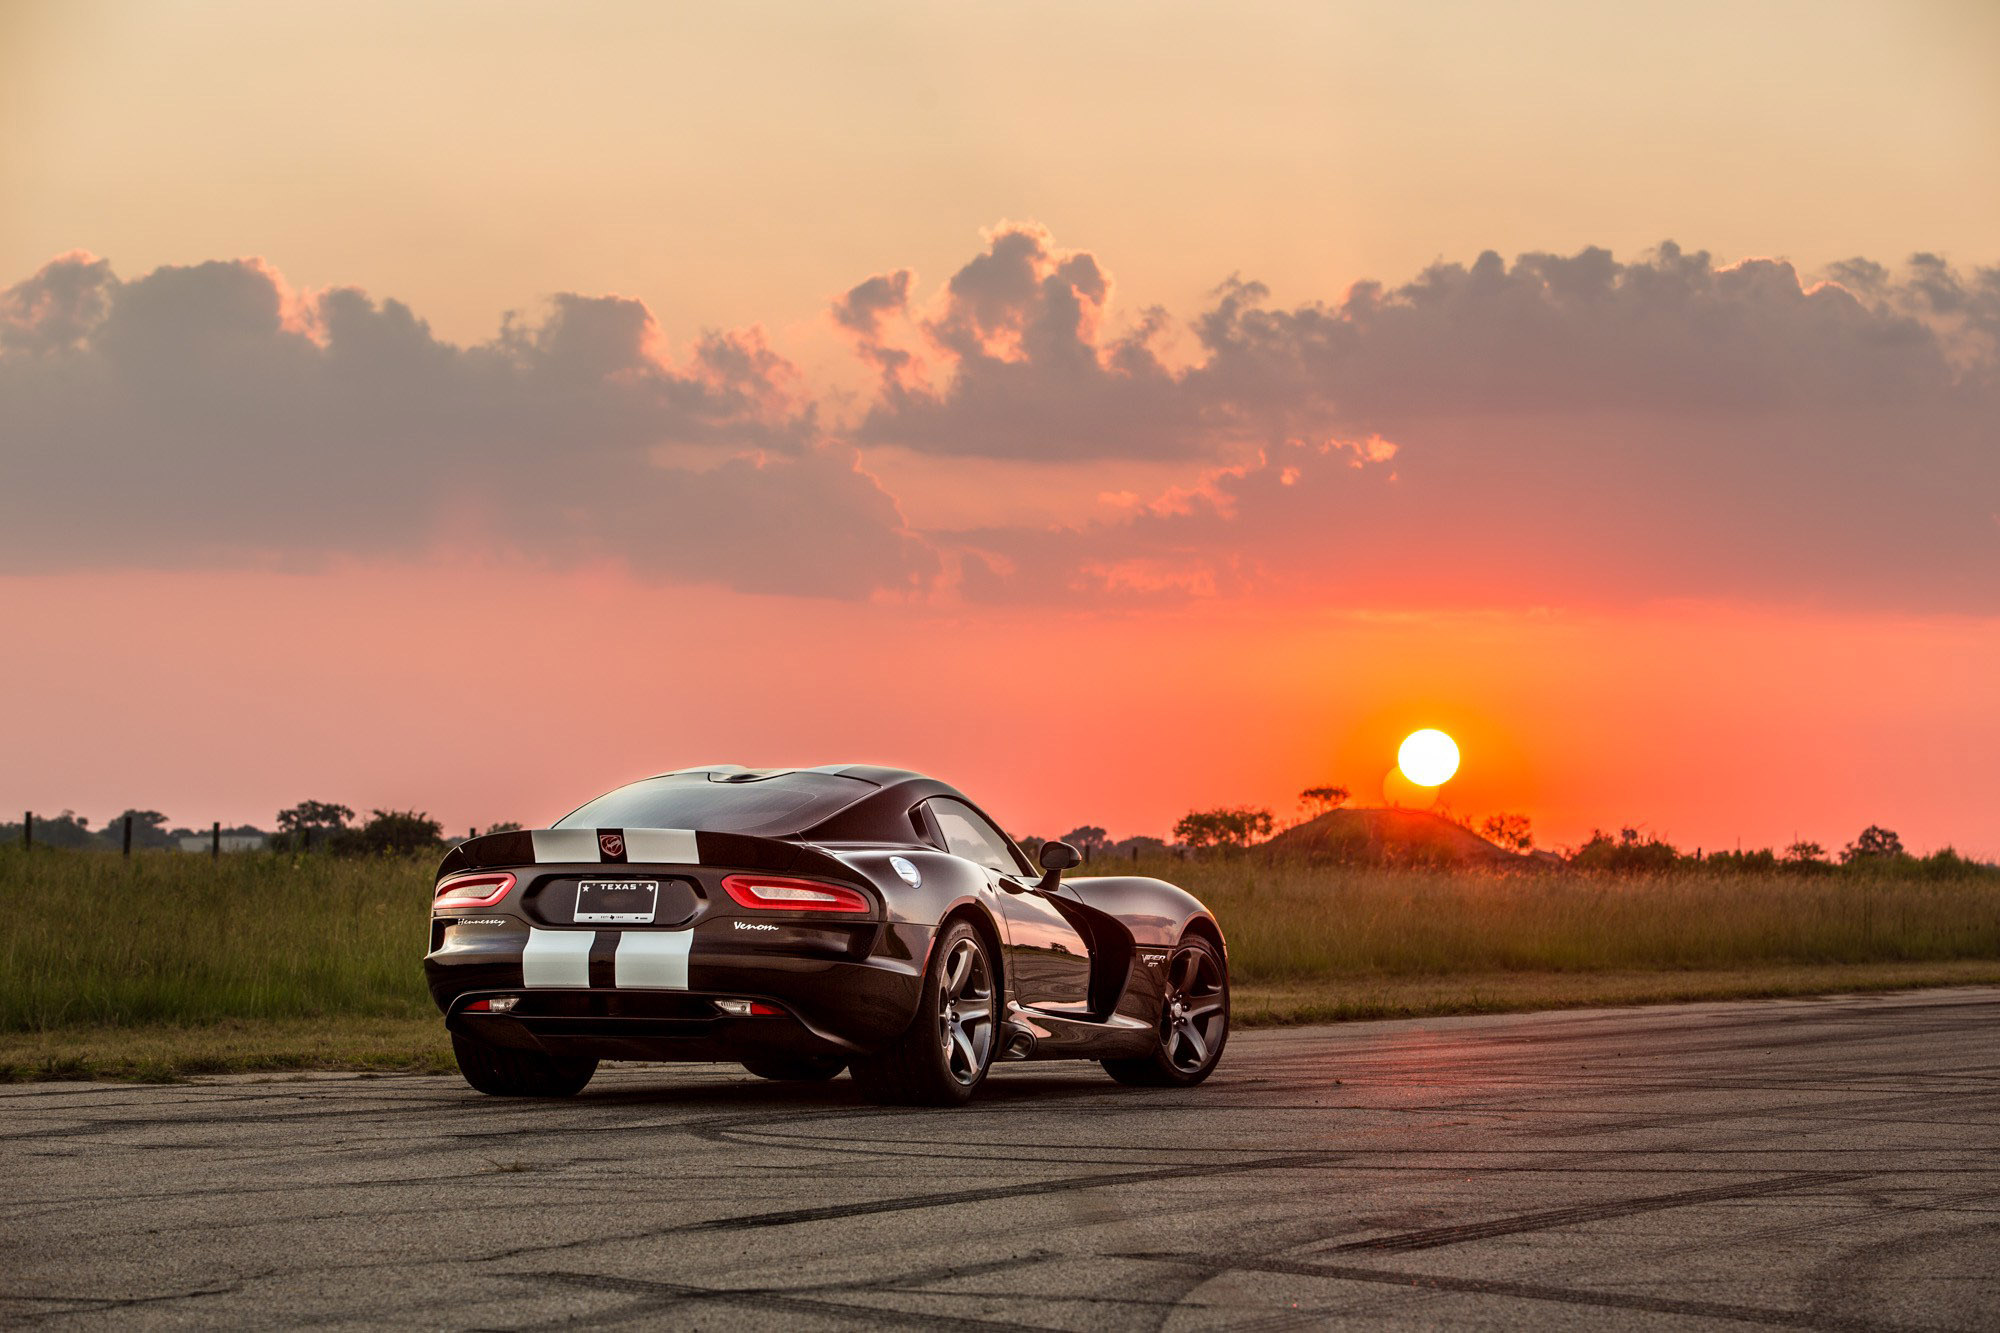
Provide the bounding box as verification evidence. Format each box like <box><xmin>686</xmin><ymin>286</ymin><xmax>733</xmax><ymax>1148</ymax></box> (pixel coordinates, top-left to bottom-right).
<box><xmin>0</xmin><ymin>233</ymin><xmax>2000</xmax><ymax>614</ymax></box>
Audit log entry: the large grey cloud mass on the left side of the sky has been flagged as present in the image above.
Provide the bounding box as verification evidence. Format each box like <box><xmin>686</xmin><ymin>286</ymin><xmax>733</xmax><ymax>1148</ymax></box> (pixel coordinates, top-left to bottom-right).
<box><xmin>0</xmin><ymin>254</ymin><xmax>936</xmax><ymax>596</ymax></box>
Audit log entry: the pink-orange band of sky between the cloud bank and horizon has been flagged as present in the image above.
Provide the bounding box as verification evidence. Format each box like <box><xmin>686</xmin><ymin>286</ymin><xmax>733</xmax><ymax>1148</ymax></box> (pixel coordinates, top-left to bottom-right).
<box><xmin>0</xmin><ymin>566</ymin><xmax>2000</xmax><ymax>857</ymax></box>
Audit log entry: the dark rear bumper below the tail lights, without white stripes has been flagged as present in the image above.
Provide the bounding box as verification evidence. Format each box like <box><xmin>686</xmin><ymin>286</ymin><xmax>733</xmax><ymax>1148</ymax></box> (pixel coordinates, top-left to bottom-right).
<box><xmin>424</xmin><ymin>921</ymin><xmax>932</xmax><ymax>1061</ymax></box>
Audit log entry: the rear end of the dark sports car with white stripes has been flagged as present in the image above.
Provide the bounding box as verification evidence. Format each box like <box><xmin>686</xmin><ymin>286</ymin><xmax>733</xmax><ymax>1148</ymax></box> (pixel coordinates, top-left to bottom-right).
<box><xmin>424</xmin><ymin>827</ymin><xmax>930</xmax><ymax>1061</ymax></box>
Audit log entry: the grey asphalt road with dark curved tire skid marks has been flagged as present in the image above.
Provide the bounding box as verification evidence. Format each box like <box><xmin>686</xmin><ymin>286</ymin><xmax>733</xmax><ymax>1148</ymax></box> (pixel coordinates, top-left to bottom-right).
<box><xmin>0</xmin><ymin>989</ymin><xmax>2000</xmax><ymax>1329</ymax></box>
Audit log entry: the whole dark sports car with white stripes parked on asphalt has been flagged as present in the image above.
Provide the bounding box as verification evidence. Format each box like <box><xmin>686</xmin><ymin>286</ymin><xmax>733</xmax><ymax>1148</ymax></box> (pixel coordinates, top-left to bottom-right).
<box><xmin>424</xmin><ymin>765</ymin><xmax>1230</xmax><ymax>1105</ymax></box>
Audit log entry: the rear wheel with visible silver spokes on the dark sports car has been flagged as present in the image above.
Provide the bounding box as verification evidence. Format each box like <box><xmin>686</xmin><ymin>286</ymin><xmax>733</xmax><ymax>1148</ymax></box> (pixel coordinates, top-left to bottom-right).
<box><xmin>850</xmin><ymin>919</ymin><xmax>1000</xmax><ymax>1107</ymax></box>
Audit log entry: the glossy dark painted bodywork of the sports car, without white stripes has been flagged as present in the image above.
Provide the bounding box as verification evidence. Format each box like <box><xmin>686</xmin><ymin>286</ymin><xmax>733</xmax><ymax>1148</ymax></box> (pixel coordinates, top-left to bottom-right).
<box><xmin>424</xmin><ymin>767</ymin><xmax>1222</xmax><ymax>1061</ymax></box>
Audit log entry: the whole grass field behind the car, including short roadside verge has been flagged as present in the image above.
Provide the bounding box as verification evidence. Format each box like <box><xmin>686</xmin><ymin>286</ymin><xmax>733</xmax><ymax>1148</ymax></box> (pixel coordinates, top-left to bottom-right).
<box><xmin>11</xmin><ymin>849</ymin><xmax>2000</xmax><ymax>1079</ymax></box>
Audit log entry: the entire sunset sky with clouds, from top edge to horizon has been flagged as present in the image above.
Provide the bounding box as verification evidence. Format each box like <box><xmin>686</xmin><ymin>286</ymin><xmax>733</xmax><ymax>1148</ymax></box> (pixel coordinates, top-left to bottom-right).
<box><xmin>0</xmin><ymin>0</ymin><xmax>2000</xmax><ymax>857</ymax></box>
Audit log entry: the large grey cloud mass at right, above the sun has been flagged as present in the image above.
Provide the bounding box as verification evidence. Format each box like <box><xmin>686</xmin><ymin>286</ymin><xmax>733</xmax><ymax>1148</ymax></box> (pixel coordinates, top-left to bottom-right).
<box><xmin>862</xmin><ymin>234</ymin><xmax>2000</xmax><ymax>612</ymax></box>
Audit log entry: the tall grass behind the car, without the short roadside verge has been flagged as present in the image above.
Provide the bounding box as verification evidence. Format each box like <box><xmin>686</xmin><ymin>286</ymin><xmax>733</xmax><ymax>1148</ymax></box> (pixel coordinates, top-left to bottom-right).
<box><xmin>0</xmin><ymin>849</ymin><xmax>2000</xmax><ymax>1033</ymax></box>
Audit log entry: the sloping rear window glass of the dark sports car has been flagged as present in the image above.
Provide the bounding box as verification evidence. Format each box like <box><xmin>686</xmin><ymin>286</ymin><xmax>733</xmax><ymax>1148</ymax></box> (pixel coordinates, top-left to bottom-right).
<box><xmin>556</xmin><ymin>773</ymin><xmax>874</xmax><ymax>837</ymax></box>
